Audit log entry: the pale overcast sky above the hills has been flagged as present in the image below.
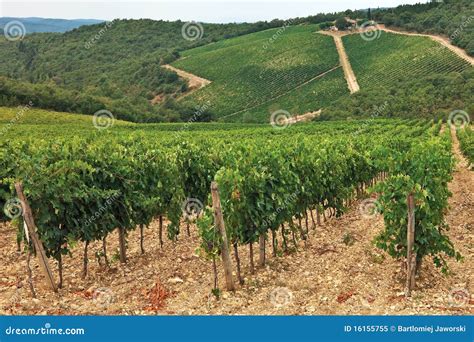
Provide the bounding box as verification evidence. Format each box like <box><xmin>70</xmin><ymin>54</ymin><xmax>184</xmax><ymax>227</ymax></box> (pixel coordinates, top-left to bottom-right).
<box><xmin>0</xmin><ymin>0</ymin><xmax>427</xmax><ymax>23</ymax></box>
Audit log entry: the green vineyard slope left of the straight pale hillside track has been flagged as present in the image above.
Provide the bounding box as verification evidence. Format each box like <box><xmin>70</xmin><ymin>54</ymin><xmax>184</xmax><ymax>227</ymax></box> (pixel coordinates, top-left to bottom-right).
<box><xmin>173</xmin><ymin>25</ymin><xmax>348</xmax><ymax>122</ymax></box>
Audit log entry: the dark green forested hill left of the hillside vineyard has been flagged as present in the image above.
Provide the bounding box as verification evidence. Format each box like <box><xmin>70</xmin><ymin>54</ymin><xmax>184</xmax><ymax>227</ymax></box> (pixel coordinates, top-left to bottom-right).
<box><xmin>0</xmin><ymin>19</ymin><xmax>283</xmax><ymax>121</ymax></box>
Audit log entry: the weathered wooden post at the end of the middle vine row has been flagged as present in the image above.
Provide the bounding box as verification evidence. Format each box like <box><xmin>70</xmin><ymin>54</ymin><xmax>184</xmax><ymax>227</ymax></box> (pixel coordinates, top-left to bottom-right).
<box><xmin>211</xmin><ymin>182</ymin><xmax>235</xmax><ymax>291</ymax></box>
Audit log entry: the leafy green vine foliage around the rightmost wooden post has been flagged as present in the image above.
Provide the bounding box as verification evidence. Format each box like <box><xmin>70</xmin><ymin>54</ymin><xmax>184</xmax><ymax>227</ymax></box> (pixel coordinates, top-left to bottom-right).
<box><xmin>375</xmin><ymin>134</ymin><xmax>461</xmax><ymax>272</ymax></box>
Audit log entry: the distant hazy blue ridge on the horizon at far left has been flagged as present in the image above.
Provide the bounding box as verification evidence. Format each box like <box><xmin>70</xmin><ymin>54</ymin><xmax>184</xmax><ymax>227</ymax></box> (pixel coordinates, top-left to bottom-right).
<box><xmin>0</xmin><ymin>17</ymin><xmax>104</xmax><ymax>34</ymax></box>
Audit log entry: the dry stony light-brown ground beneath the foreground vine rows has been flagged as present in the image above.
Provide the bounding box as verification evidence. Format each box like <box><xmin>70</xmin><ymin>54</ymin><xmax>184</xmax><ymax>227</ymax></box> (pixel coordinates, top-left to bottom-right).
<box><xmin>0</xmin><ymin>131</ymin><xmax>474</xmax><ymax>315</ymax></box>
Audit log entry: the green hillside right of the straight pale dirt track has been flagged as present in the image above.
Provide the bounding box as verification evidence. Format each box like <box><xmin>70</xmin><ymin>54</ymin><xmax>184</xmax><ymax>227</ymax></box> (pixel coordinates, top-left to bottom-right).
<box><xmin>320</xmin><ymin>31</ymin><xmax>474</xmax><ymax>120</ymax></box>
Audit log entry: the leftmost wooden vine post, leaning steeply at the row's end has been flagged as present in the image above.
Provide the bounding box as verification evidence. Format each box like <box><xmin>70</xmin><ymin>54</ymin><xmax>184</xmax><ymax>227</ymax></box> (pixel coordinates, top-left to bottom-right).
<box><xmin>15</xmin><ymin>182</ymin><xmax>58</xmax><ymax>292</ymax></box>
